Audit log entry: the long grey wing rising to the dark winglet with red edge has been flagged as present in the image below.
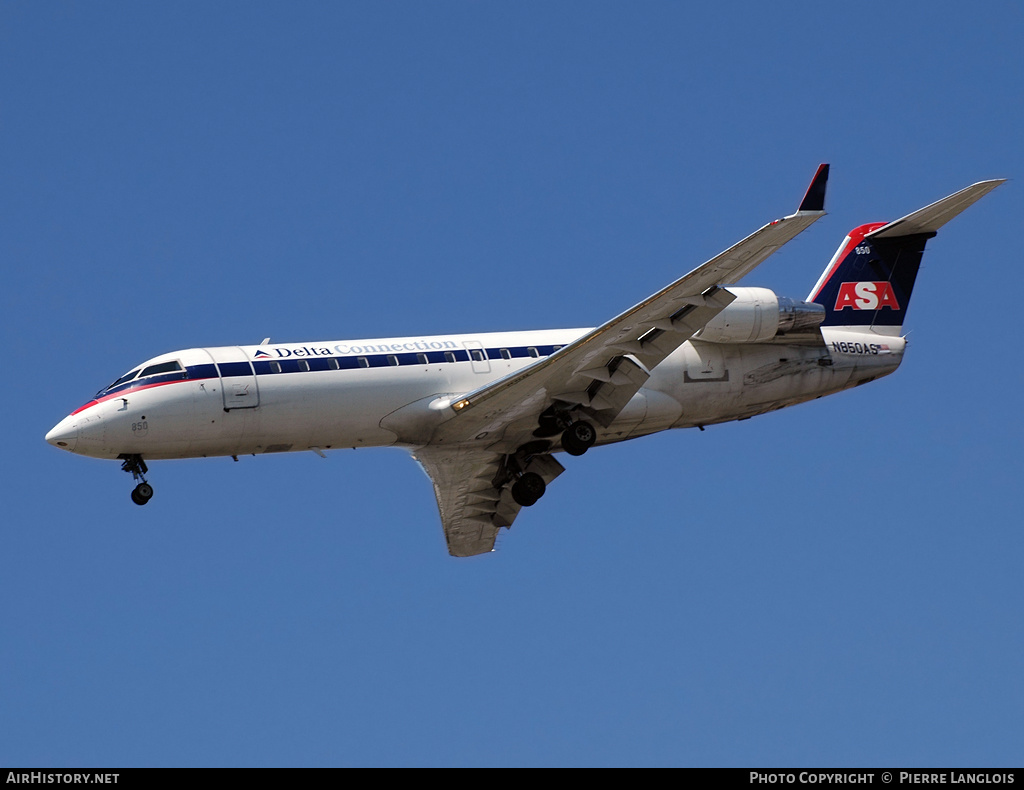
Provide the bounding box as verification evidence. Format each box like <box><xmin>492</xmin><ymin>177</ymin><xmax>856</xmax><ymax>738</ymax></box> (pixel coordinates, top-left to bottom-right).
<box><xmin>431</xmin><ymin>165</ymin><xmax>828</xmax><ymax>452</ymax></box>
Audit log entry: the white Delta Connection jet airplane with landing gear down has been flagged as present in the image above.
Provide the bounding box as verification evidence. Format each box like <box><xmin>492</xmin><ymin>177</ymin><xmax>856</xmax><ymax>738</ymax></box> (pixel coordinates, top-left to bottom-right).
<box><xmin>46</xmin><ymin>164</ymin><xmax>1006</xmax><ymax>556</ymax></box>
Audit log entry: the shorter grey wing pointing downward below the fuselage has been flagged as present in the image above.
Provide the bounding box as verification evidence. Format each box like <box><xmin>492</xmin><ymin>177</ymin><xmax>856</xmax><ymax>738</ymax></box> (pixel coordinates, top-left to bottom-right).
<box><xmin>413</xmin><ymin>447</ymin><xmax>565</xmax><ymax>556</ymax></box>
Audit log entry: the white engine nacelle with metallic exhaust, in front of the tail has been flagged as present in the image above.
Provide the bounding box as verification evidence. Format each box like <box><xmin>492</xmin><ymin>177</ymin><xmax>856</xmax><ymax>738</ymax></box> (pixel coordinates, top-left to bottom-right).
<box><xmin>693</xmin><ymin>286</ymin><xmax>825</xmax><ymax>343</ymax></box>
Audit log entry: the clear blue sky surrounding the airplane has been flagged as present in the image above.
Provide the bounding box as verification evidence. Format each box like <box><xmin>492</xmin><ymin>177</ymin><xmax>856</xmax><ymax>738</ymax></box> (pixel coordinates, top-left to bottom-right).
<box><xmin>0</xmin><ymin>2</ymin><xmax>1024</xmax><ymax>766</ymax></box>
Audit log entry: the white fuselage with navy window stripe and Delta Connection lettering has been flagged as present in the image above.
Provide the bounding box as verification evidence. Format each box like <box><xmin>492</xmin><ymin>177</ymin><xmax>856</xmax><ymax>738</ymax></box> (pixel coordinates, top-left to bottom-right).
<box><xmin>47</xmin><ymin>328</ymin><xmax>905</xmax><ymax>460</ymax></box>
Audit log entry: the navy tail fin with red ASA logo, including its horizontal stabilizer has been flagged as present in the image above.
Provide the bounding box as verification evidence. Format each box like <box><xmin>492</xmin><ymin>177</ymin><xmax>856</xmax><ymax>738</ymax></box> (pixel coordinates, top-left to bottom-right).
<box><xmin>807</xmin><ymin>178</ymin><xmax>1006</xmax><ymax>335</ymax></box>
